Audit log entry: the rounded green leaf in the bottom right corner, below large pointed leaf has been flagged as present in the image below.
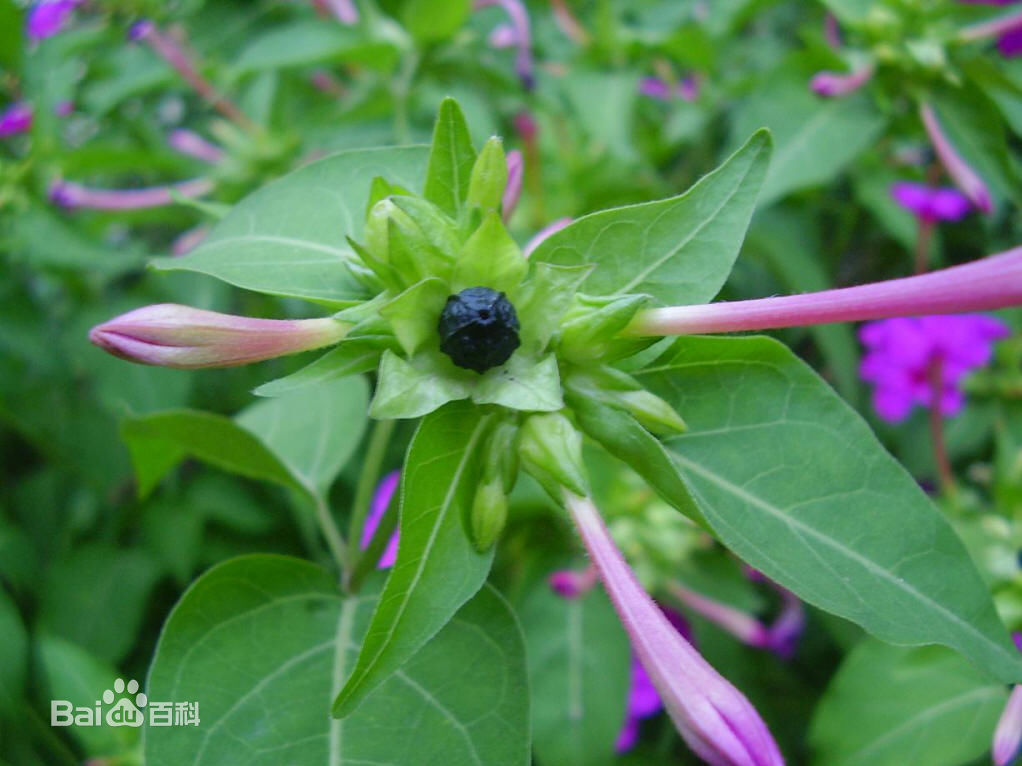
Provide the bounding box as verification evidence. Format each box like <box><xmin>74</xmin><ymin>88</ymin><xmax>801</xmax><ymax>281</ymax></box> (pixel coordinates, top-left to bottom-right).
<box><xmin>809</xmin><ymin>640</ymin><xmax>1008</xmax><ymax>766</ymax></box>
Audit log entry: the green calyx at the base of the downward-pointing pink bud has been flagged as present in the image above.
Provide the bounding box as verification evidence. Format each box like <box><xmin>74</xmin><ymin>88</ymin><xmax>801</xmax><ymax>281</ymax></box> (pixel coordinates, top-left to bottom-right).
<box><xmin>518</xmin><ymin>413</ymin><xmax>589</xmax><ymax>502</ymax></box>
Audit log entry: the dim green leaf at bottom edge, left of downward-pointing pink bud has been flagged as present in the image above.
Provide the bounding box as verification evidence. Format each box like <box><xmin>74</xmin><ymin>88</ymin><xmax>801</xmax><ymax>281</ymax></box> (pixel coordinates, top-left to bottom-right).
<box><xmin>519</xmin><ymin>581</ymin><xmax>632</xmax><ymax>766</ymax></box>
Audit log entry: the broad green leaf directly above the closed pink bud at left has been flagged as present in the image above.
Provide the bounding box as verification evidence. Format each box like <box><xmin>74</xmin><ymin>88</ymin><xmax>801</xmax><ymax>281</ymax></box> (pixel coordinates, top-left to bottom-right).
<box><xmin>152</xmin><ymin>146</ymin><xmax>426</xmax><ymax>307</ymax></box>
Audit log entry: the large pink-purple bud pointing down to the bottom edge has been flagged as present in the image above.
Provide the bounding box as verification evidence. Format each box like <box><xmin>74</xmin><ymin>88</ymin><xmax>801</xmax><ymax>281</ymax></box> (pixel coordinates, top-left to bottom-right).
<box><xmin>565</xmin><ymin>492</ymin><xmax>784</xmax><ymax>766</ymax></box>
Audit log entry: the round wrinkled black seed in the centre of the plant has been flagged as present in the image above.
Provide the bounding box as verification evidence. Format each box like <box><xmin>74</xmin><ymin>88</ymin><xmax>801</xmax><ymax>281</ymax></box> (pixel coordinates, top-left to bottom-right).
<box><xmin>436</xmin><ymin>287</ymin><xmax>521</xmax><ymax>373</ymax></box>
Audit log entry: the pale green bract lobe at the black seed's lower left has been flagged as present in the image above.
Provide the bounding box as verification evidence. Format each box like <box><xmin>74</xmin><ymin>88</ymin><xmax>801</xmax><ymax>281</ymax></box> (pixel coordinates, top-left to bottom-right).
<box><xmin>369</xmin><ymin>351</ymin><xmax>472</xmax><ymax>420</ymax></box>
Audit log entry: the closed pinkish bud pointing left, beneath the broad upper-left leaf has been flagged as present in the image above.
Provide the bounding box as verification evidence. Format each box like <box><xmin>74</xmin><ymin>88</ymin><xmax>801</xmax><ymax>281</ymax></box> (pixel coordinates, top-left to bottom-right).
<box><xmin>89</xmin><ymin>303</ymin><xmax>351</xmax><ymax>370</ymax></box>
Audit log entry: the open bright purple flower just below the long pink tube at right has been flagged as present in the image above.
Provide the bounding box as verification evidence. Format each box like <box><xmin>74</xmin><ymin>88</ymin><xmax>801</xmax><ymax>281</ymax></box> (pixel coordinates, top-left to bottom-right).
<box><xmin>858</xmin><ymin>315</ymin><xmax>1011</xmax><ymax>423</ymax></box>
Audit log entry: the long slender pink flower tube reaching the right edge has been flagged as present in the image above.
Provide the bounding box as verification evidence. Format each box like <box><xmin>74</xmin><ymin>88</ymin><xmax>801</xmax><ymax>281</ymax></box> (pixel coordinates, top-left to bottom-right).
<box><xmin>624</xmin><ymin>246</ymin><xmax>1022</xmax><ymax>335</ymax></box>
